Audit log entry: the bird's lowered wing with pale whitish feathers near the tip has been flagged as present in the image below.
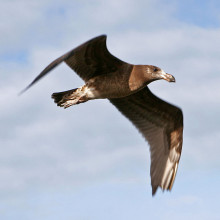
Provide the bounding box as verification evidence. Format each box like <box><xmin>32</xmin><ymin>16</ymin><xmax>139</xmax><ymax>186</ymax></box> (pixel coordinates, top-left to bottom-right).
<box><xmin>110</xmin><ymin>87</ymin><xmax>183</xmax><ymax>195</ymax></box>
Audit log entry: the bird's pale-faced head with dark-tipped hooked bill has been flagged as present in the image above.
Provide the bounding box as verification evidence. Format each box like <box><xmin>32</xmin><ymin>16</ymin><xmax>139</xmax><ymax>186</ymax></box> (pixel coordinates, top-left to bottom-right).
<box><xmin>145</xmin><ymin>65</ymin><xmax>175</xmax><ymax>82</ymax></box>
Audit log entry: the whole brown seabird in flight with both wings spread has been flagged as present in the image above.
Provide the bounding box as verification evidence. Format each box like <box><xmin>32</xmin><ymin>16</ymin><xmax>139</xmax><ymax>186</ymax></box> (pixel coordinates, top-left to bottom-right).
<box><xmin>21</xmin><ymin>35</ymin><xmax>183</xmax><ymax>195</ymax></box>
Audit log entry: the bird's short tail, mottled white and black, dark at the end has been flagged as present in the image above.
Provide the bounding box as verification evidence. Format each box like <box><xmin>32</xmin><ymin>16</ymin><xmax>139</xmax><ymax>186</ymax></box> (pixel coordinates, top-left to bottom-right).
<box><xmin>51</xmin><ymin>88</ymin><xmax>87</xmax><ymax>108</ymax></box>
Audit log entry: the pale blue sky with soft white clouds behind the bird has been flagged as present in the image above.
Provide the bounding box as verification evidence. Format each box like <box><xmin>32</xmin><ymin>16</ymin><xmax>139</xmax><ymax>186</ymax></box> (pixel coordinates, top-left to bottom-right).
<box><xmin>0</xmin><ymin>0</ymin><xmax>220</xmax><ymax>220</ymax></box>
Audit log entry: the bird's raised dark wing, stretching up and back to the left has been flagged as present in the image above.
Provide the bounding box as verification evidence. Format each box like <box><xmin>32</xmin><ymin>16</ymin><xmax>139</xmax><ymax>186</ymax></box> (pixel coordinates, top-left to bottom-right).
<box><xmin>21</xmin><ymin>35</ymin><xmax>126</xmax><ymax>93</ymax></box>
